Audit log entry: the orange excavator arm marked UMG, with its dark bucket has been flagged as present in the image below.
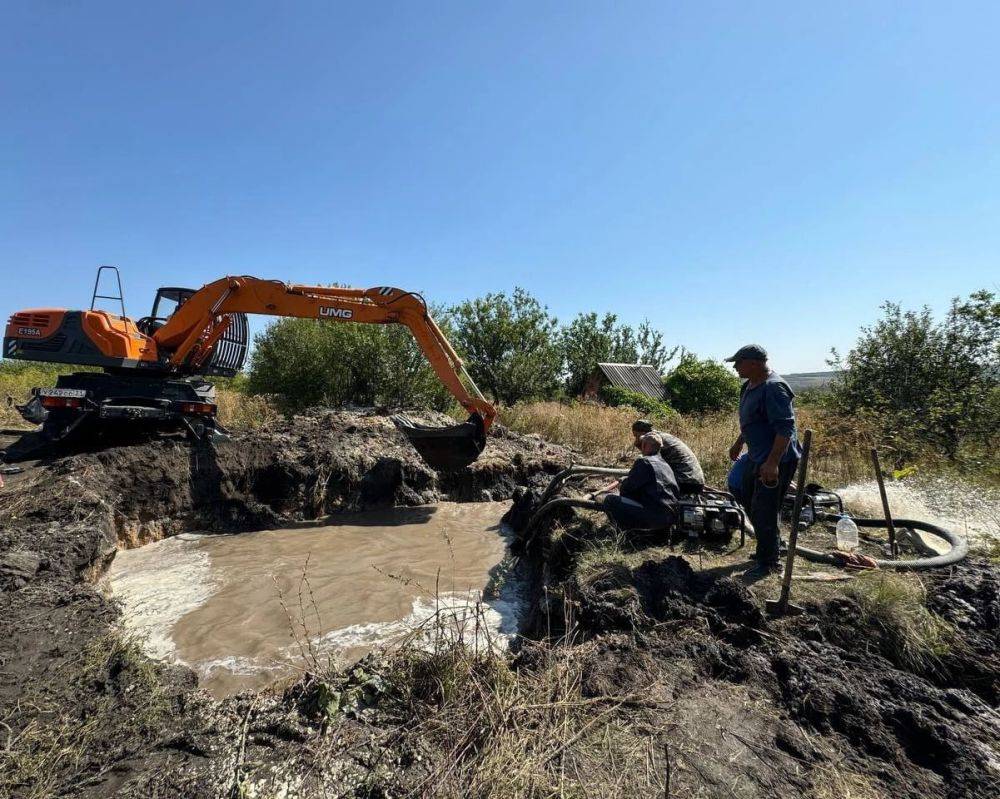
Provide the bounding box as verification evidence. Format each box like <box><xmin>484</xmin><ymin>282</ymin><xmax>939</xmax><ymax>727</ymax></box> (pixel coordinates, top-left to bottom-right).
<box><xmin>153</xmin><ymin>277</ymin><xmax>496</xmax><ymax>468</ymax></box>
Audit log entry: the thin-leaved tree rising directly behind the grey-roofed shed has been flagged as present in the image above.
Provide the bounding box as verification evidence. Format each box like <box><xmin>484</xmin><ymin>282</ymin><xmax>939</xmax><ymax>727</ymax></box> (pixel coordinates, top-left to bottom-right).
<box><xmin>559</xmin><ymin>313</ymin><xmax>677</xmax><ymax>396</ymax></box>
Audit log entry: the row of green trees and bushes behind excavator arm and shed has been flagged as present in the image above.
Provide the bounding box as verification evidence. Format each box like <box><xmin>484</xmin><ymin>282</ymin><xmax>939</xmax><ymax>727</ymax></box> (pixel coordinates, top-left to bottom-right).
<box><xmin>246</xmin><ymin>288</ymin><xmax>739</xmax><ymax>412</ymax></box>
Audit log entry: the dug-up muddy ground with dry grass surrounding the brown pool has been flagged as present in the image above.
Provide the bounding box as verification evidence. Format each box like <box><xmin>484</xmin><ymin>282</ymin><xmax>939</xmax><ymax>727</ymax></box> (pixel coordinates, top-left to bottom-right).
<box><xmin>0</xmin><ymin>411</ymin><xmax>1000</xmax><ymax>799</ymax></box>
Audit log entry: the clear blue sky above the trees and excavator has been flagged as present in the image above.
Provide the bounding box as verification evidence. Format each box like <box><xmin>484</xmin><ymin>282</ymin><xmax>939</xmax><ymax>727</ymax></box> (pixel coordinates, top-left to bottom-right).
<box><xmin>0</xmin><ymin>0</ymin><xmax>1000</xmax><ymax>372</ymax></box>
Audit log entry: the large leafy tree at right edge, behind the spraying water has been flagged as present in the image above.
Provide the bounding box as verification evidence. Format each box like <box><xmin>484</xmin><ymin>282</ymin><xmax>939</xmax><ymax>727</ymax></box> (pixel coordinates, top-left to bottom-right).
<box><xmin>830</xmin><ymin>291</ymin><xmax>1000</xmax><ymax>459</ymax></box>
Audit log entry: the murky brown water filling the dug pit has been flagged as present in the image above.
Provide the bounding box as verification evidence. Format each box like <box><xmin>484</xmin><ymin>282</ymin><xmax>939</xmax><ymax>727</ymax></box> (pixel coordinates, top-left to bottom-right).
<box><xmin>109</xmin><ymin>503</ymin><xmax>520</xmax><ymax>696</ymax></box>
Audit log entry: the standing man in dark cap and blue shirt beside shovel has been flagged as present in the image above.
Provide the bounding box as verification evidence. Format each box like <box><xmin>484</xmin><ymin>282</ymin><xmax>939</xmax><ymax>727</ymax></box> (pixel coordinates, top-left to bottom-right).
<box><xmin>726</xmin><ymin>344</ymin><xmax>801</xmax><ymax>577</ymax></box>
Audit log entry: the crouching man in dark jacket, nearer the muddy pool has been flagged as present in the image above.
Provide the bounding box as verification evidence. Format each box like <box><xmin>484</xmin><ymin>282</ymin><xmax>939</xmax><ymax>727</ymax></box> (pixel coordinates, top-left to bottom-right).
<box><xmin>599</xmin><ymin>433</ymin><xmax>678</xmax><ymax>530</ymax></box>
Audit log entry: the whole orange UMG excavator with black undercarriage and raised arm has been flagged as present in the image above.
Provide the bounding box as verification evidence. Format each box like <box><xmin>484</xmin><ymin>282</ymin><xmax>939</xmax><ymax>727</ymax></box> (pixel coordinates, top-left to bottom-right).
<box><xmin>3</xmin><ymin>267</ymin><xmax>496</xmax><ymax>469</ymax></box>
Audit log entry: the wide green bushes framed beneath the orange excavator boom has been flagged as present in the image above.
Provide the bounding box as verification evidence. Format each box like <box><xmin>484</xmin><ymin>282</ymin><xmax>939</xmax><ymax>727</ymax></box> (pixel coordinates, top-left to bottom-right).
<box><xmin>247</xmin><ymin>319</ymin><xmax>452</xmax><ymax>412</ymax></box>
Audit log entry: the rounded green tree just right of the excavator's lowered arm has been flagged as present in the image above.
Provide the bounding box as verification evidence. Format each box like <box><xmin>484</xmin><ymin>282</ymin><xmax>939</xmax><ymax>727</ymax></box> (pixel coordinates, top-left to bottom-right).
<box><xmin>449</xmin><ymin>288</ymin><xmax>562</xmax><ymax>405</ymax></box>
